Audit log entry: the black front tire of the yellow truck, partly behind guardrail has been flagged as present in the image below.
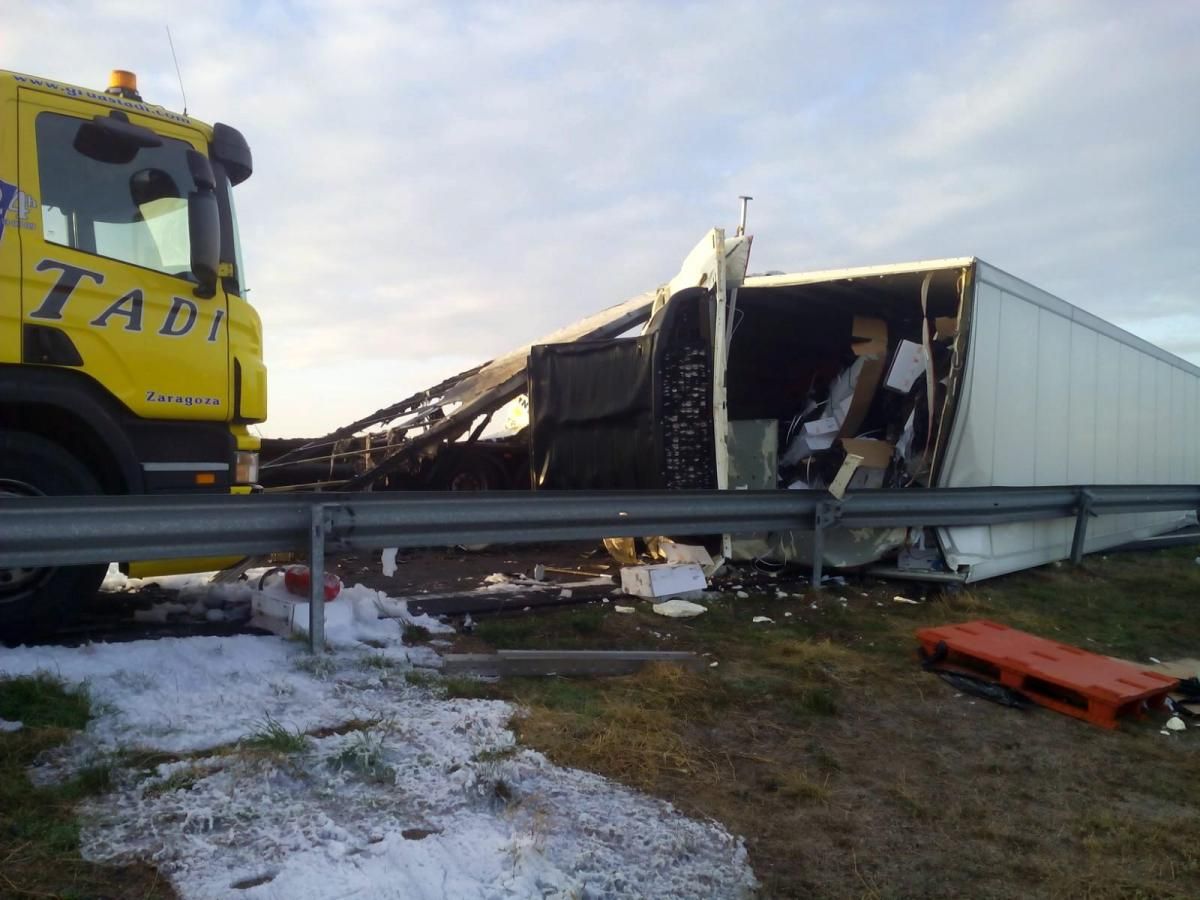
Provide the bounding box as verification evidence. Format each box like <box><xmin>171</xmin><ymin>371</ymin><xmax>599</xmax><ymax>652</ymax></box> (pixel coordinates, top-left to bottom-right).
<box><xmin>0</xmin><ymin>431</ymin><xmax>108</xmax><ymax>640</ymax></box>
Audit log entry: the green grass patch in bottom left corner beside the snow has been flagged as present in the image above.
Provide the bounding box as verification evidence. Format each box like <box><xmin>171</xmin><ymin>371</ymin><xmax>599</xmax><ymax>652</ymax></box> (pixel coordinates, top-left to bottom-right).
<box><xmin>0</xmin><ymin>674</ymin><xmax>174</xmax><ymax>899</ymax></box>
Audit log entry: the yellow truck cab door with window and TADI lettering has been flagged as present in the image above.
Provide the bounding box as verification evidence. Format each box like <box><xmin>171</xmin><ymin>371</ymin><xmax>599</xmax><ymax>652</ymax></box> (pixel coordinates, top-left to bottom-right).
<box><xmin>18</xmin><ymin>89</ymin><xmax>229</xmax><ymax>421</ymax></box>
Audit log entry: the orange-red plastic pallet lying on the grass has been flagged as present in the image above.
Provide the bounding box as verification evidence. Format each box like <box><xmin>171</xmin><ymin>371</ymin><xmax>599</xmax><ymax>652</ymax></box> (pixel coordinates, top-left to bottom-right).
<box><xmin>917</xmin><ymin>619</ymin><xmax>1178</xmax><ymax>728</ymax></box>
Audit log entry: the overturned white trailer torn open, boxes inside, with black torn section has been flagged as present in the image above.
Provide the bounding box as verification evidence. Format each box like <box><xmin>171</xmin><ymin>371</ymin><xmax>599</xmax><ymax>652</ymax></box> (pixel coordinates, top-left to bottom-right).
<box><xmin>529</xmin><ymin>258</ymin><xmax>1200</xmax><ymax>581</ymax></box>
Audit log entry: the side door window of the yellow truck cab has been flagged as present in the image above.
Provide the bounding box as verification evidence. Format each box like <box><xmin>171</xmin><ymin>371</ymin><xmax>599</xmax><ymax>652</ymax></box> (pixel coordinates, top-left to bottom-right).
<box><xmin>37</xmin><ymin>113</ymin><xmax>194</xmax><ymax>278</ymax></box>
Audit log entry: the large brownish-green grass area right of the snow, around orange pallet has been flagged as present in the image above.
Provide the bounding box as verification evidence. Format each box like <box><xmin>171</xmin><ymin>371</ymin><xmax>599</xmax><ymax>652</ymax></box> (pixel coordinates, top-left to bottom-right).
<box><xmin>453</xmin><ymin>547</ymin><xmax>1200</xmax><ymax>900</ymax></box>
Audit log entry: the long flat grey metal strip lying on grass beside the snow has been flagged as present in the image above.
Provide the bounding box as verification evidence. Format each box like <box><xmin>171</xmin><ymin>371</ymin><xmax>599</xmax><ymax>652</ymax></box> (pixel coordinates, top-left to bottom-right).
<box><xmin>442</xmin><ymin>650</ymin><xmax>703</xmax><ymax>677</ymax></box>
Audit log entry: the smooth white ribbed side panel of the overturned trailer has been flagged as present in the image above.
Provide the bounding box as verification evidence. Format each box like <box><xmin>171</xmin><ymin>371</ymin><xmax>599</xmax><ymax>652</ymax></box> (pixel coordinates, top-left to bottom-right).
<box><xmin>938</xmin><ymin>262</ymin><xmax>1200</xmax><ymax>581</ymax></box>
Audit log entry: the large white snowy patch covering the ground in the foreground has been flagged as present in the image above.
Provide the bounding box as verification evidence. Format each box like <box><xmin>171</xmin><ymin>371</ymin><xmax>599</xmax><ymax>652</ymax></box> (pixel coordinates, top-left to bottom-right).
<box><xmin>0</xmin><ymin>638</ymin><xmax>755</xmax><ymax>900</ymax></box>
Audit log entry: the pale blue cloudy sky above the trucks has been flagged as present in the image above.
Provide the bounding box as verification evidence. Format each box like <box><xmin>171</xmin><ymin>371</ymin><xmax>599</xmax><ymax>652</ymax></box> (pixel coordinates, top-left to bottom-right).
<box><xmin>0</xmin><ymin>0</ymin><xmax>1200</xmax><ymax>437</ymax></box>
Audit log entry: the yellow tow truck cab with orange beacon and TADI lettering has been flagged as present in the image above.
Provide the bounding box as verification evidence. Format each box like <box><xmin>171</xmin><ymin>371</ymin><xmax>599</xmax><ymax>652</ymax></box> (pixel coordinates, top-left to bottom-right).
<box><xmin>0</xmin><ymin>71</ymin><xmax>266</xmax><ymax>631</ymax></box>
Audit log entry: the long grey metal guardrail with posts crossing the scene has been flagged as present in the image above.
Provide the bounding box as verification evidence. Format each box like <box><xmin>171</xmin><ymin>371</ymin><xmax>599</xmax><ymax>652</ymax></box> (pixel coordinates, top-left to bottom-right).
<box><xmin>0</xmin><ymin>485</ymin><xmax>1200</xmax><ymax>647</ymax></box>
